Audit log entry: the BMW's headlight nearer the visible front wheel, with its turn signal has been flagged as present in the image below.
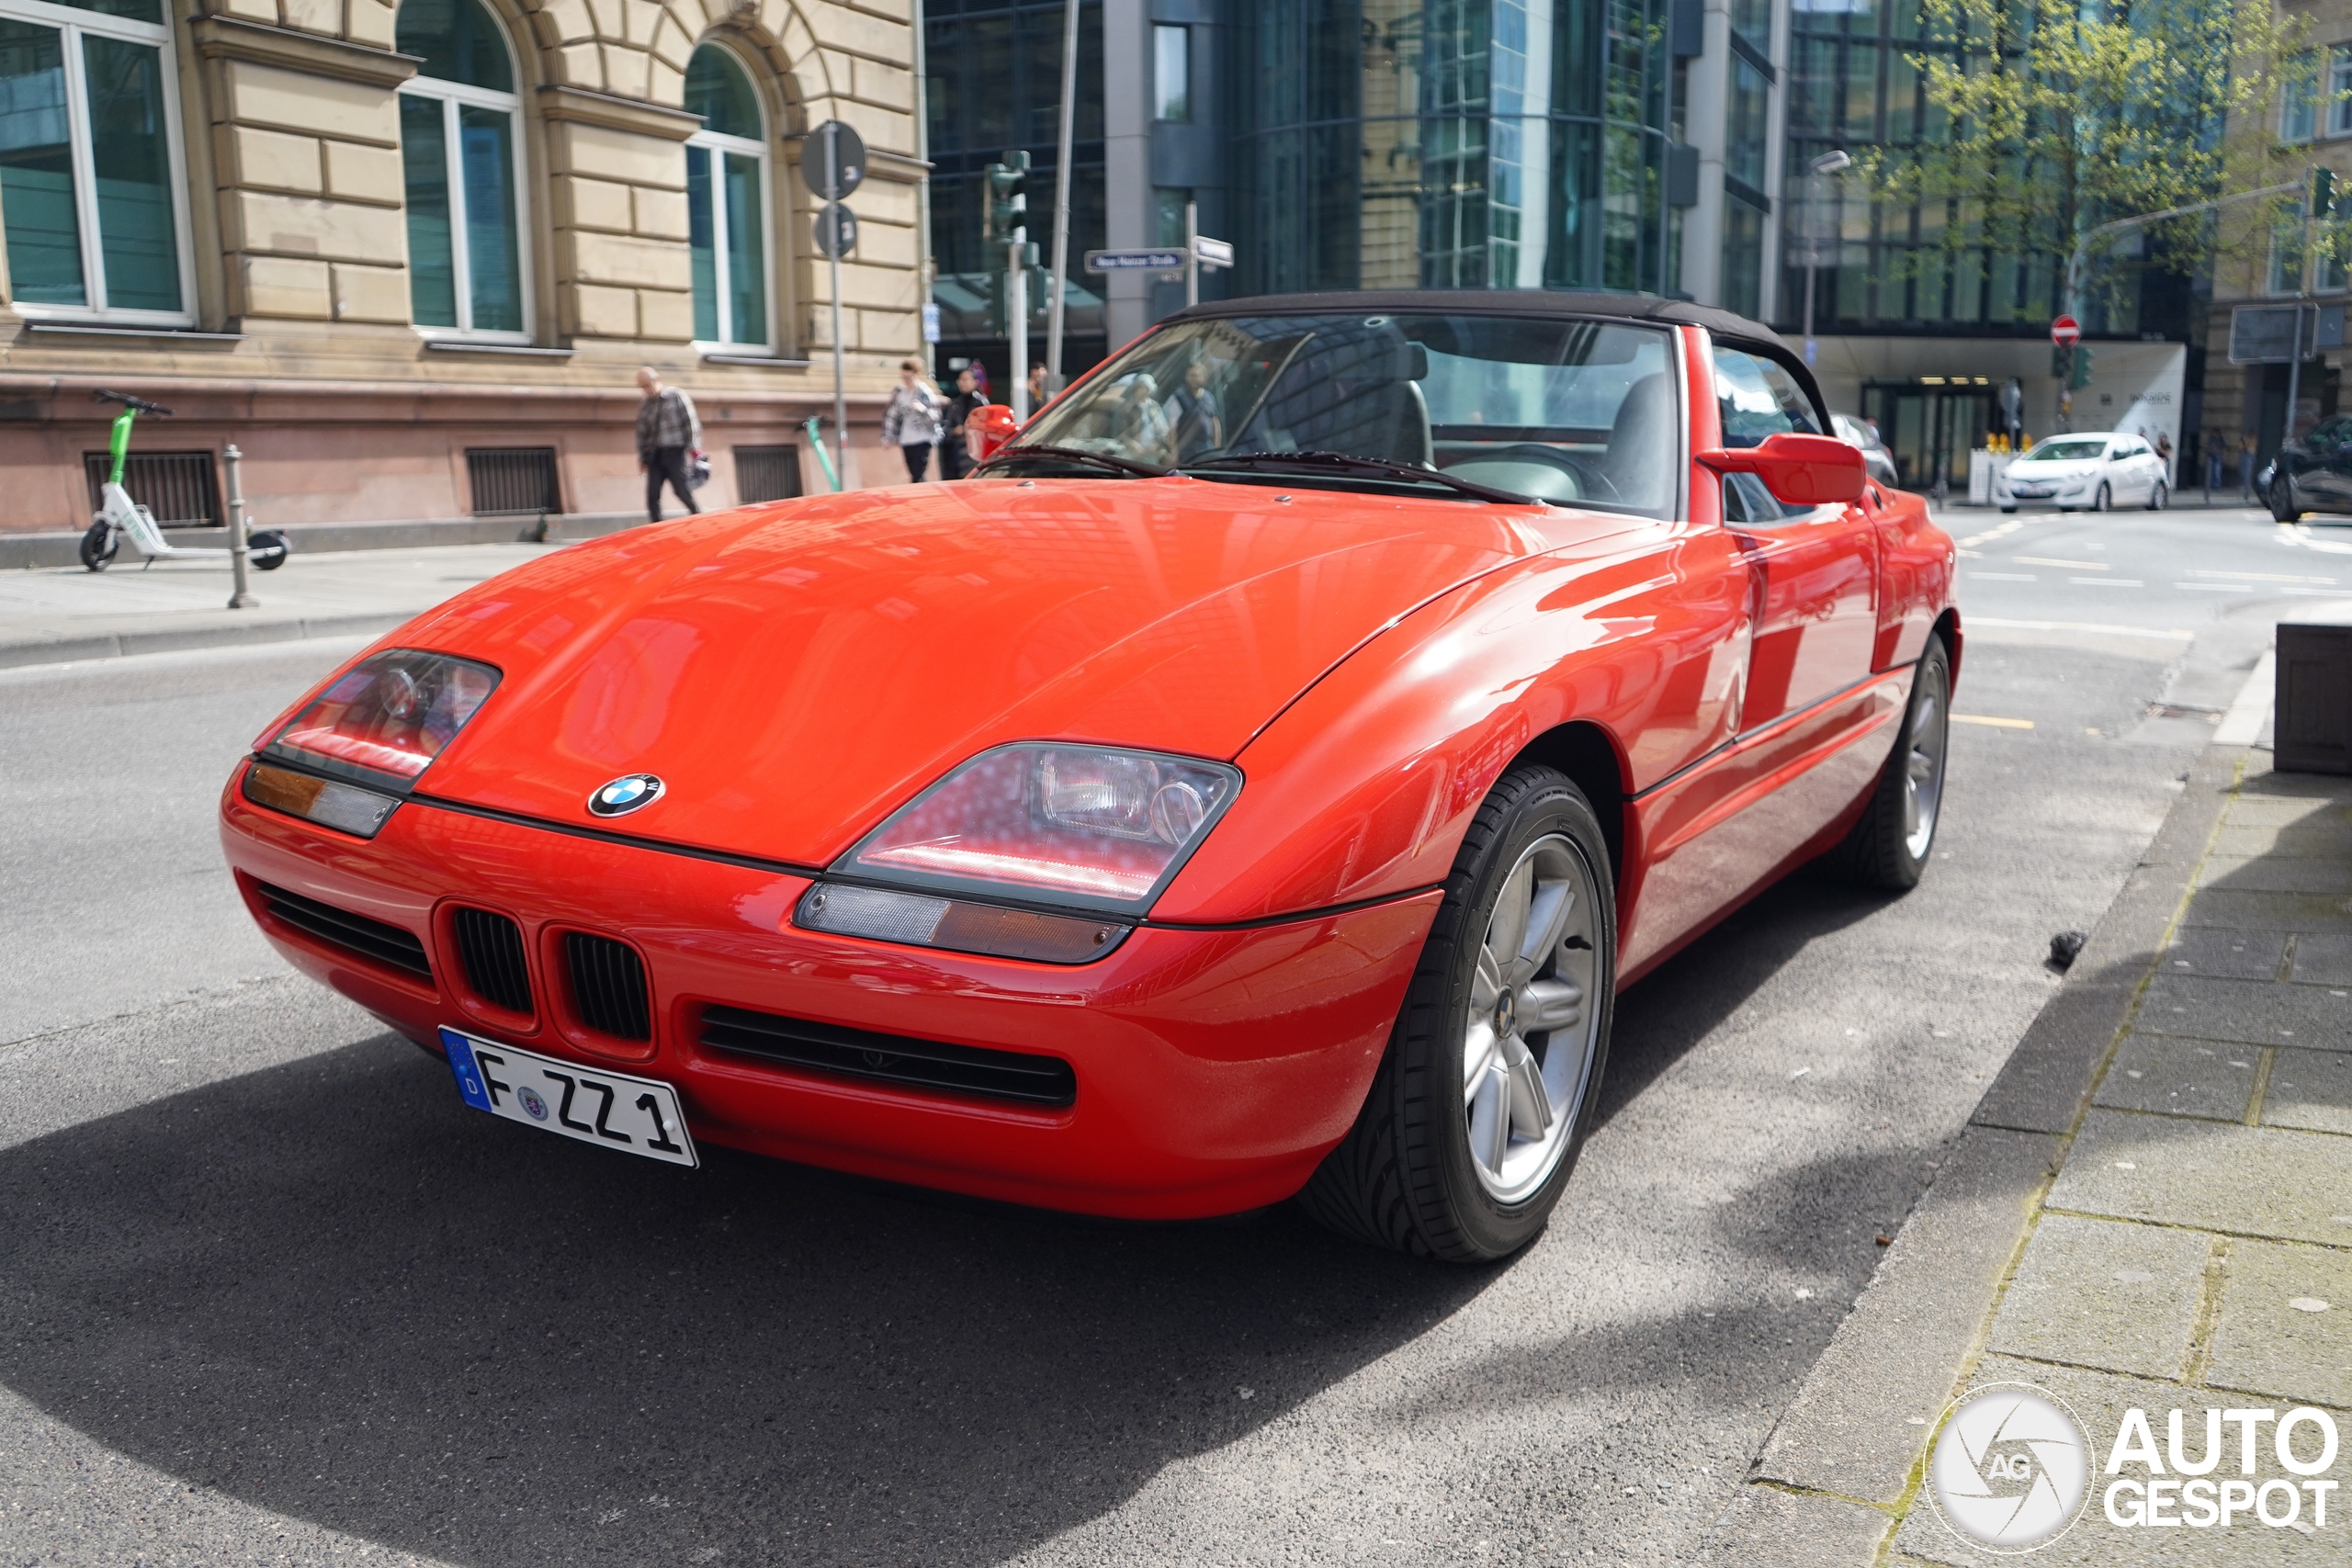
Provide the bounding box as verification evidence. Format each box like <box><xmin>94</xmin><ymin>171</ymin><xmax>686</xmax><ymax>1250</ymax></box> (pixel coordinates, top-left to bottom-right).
<box><xmin>793</xmin><ymin>740</ymin><xmax>1242</xmax><ymax>964</ymax></box>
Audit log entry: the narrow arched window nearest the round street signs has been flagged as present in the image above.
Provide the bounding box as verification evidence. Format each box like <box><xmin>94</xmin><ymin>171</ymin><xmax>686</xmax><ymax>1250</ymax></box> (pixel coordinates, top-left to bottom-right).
<box><xmin>687</xmin><ymin>45</ymin><xmax>774</xmax><ymax>348</ymax></box>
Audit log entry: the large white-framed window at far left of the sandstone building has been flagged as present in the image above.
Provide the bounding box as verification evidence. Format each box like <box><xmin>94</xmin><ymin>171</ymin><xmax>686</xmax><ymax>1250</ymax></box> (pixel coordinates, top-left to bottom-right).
<box><xmin>0</xmin><ymin>0</ymin><xmax>193</xmax><ymax>324</ymax></box>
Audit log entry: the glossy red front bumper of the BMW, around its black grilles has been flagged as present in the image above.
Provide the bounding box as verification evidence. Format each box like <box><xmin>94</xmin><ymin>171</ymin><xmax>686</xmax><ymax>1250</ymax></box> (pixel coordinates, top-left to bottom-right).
<box><xmin>221</xmin><ymin>766</ymin><xmax>1437</xmax><ymax>1218</ymax></box>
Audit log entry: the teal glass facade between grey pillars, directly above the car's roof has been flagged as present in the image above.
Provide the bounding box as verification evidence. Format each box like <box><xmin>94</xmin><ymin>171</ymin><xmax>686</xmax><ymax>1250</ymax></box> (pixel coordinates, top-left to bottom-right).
<box><xmin>1232</xmin><ymin>0</ymin><xmax>1679</xmax><ymax>294</ymax></box>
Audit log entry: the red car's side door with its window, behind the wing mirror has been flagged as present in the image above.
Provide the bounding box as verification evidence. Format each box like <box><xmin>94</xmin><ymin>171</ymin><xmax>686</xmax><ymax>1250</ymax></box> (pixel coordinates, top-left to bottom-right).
<box><xmin>1714</xmin><ymin>344</ymin><xmax>1877</xmax><ymax>731</ymax></box>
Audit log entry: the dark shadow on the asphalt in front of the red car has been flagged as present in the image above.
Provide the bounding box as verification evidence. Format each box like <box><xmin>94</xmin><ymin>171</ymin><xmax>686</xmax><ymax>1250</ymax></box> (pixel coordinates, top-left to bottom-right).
<box><xmin>0</xmin><ymin>1037</ymin><xmax>1496</xmax><ymax>1565</ymax></box>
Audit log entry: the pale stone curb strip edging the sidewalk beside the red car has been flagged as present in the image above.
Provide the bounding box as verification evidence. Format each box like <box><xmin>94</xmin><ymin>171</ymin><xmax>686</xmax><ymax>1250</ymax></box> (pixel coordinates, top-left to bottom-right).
<box><xmin>1698</xmin><ymin>745</ymin><xmax>2246</xmax><ymax>1568</ymax></box>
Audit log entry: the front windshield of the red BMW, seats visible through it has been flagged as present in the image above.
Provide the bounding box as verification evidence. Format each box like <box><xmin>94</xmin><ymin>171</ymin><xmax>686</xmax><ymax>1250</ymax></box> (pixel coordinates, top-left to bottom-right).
<box><xmin>997</xmin><ymin>312</ymin><xmax>1679</xmax><ymax>517</ymax></box>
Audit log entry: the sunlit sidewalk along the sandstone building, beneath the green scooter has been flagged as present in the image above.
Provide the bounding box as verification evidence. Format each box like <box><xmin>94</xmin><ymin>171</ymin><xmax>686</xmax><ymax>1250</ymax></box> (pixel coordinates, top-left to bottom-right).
<box><xmin>0</xmin><ymin>543</ymin><xmax>564</xmax><ymax>668</ymax></box>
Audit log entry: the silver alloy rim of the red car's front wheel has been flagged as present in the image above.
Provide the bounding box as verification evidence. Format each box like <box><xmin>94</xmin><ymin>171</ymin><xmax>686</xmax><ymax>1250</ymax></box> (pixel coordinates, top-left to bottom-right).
<box><xmin>1463</xmin><ymin>832</ymin><xmax>1600</xmax><ymax>1203</ymax></box>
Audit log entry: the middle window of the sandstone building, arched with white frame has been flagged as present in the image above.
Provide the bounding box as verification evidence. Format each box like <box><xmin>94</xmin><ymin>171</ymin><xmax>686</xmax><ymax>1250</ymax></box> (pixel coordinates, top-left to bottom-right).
<box><xmin>395</xmin><ymin>0</ymin><xmax>529</xmax><ymax>339</ymax></box>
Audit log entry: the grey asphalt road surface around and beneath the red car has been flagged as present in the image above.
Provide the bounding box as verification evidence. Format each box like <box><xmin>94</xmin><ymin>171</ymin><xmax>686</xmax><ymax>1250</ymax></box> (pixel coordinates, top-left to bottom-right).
<box><xmin>0</xmin><ymin>513</ymin><xmax>2352</xmax><ymax>1568</ymax></box>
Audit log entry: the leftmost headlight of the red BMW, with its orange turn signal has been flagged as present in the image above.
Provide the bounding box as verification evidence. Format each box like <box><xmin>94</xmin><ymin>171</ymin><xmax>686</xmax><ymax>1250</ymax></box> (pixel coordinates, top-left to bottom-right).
<box><xmin>244</xmin><ymin>649</ymin><xmax>499</xmax><ymax>837</ymax></box>
